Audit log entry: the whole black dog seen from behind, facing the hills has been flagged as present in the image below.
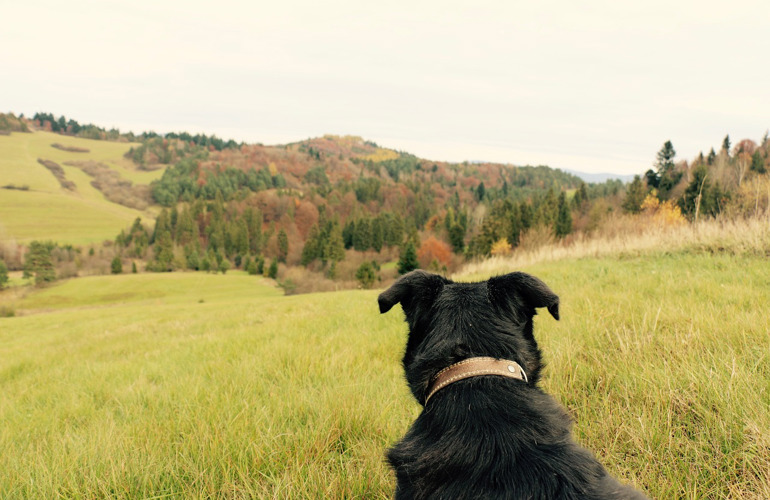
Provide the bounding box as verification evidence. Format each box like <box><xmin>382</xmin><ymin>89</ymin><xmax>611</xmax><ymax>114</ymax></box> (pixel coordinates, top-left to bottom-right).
<box><xmin>378</xmin><ymin>271</ymin><xmax>645</xmax><ymax>499</ymax></box>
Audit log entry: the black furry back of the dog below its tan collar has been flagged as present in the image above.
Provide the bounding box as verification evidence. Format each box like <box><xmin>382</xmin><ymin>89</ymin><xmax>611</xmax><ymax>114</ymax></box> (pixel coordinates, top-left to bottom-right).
<box><xmin>388</xmin><ymin>376</ymin><xmax>645</xmax><ymax>499</ymax></box>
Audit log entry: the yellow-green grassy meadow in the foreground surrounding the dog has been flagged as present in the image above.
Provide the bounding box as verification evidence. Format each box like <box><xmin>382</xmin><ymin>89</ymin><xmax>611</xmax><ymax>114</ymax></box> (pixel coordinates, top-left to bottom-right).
<box><xmin>0</xmin><ymin>251</ymin><xmax>770</xmax><ymax>499</ymax></box>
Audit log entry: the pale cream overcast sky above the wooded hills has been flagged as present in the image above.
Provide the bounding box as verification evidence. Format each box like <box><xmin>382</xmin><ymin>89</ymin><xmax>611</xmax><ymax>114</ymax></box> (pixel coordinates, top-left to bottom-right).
<box><xmin>0</xmin><ymin>0</ymin><xmax>770</xmax><ymax>173</ymax></box>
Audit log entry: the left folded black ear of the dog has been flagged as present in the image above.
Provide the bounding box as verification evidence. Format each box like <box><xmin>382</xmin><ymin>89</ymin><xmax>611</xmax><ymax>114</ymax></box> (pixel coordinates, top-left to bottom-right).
<box><xmin>377</xmin><ymin>269</ymin><xmax>451</xmax><ymax>322</ymax></box>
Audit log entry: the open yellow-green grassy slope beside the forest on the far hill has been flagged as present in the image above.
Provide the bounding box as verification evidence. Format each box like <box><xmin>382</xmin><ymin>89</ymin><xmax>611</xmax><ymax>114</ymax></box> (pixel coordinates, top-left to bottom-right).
<box><xmin>0</xmin><ymin>132</ymin><xmax>161</xmax><ymax>244</ymax></box>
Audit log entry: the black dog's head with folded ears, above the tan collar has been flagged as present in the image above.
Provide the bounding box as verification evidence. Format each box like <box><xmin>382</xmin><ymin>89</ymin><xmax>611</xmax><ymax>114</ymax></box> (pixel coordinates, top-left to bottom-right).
<box><xmin>378</xmin><ymin>270</ymin><xmax>559</xmax><ymax>402</ymax></box>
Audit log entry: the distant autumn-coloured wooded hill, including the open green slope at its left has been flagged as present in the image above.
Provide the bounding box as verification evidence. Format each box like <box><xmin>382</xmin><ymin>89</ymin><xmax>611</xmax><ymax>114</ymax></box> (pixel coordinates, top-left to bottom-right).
<box><xmin>0</xmin><ymin>113</ymin><xmax>621</xmax><ymax>289</ymax></box>
